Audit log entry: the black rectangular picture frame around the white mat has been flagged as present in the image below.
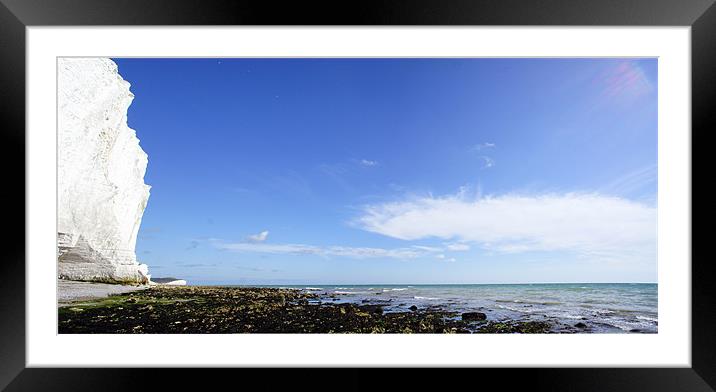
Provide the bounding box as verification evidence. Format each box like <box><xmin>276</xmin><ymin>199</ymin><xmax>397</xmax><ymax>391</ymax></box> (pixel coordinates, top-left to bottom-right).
<box><xmin>0</xmin><ymin>0</ymin><xmax>716</xmax><ymax>392</ymax></box>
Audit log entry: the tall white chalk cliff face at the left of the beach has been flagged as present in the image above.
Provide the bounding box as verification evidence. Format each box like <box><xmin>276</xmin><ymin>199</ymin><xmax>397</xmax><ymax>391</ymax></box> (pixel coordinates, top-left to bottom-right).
<box><xmin>57</xmin><ymin>58</ymin><xmax>149</xmax><ymax>283</ymax></box>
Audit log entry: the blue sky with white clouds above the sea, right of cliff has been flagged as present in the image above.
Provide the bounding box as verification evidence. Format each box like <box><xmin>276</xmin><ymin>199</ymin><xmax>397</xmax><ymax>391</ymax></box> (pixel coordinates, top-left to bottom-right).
<box><xmin>115</xmin><ymin>59</ymin><xmax>657</xmax><ymax>284</ymax></box>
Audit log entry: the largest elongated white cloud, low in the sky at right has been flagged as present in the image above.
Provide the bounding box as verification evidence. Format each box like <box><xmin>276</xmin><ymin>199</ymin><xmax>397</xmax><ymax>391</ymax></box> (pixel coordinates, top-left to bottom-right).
<box><xmin>355</xmin><ymin>192</ymin><xmax>657</xmax><ymax>259</ymax></box>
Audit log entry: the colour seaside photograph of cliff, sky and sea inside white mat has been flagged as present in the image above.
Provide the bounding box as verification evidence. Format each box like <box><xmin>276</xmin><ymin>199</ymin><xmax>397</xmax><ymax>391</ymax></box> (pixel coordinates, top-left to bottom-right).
<box><xmin>58</xmin><ymin>57</ymin><xmax>656</xmax><ymax>339</ymax></box>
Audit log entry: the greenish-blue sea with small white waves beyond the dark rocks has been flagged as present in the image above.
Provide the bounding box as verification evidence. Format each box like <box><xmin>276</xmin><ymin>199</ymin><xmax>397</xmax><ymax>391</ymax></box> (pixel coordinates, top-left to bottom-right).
<box><xmin>266</xmin><ymin>283</ymin><xmax>659</xmax><ymax>333</ymax></box>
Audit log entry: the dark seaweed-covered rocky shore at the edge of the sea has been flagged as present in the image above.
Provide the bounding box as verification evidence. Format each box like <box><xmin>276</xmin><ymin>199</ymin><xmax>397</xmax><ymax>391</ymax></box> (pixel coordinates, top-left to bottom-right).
<box><xmin>58</xmin><ymin>286</ymin><xmax>608</xmax><ymax>334</ymax></box>
